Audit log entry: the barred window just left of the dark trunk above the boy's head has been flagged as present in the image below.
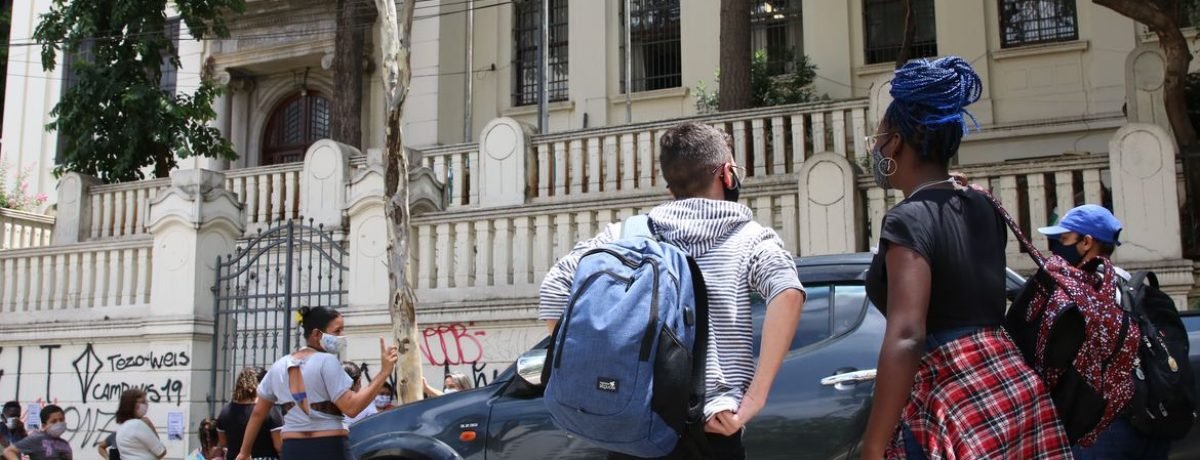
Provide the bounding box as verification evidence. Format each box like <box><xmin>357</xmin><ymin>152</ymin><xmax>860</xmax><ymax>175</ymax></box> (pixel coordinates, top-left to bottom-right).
<box><xmin>619</xmin><ymin>0</ymin><xmax>681</xmax><ymax>94</ymax></box>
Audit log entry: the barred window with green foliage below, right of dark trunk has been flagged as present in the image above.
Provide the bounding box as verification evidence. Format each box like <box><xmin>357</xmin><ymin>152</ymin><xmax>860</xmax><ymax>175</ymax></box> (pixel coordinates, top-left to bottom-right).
<box><xmin>750</xmin><ymin>0</ymin><xmax>804</xmax><ymax>76</ymax></box>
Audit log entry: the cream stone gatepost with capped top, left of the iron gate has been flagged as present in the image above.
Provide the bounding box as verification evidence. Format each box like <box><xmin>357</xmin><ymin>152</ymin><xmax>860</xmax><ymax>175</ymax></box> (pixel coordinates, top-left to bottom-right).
<box><xmin>146</xmin><ymin>169</ymin><xmax>245</xmax><ymax>318</ymax></box>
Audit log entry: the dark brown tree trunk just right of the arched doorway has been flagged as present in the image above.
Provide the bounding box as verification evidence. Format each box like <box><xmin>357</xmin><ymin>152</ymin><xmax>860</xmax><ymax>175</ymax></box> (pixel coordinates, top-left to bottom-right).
<box><xmin>330</xmin><ymin>0</ymin><xmax>372</xmax><ymax>149</ymax></box>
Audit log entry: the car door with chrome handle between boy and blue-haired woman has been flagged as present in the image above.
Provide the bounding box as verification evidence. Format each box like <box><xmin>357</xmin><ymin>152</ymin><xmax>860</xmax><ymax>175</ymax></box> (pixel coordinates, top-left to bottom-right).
<box><xmin>744</xmin><ymin>281</ymin><xmax>884</xmax><ymax>460</ymax></box>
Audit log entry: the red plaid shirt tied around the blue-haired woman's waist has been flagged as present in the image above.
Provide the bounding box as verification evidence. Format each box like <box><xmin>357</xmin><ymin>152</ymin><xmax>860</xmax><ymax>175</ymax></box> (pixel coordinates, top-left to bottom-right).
<box><xmin>887</xmin><ymin>329</ymin><xmax>1070</xmax><ymax>460</ymax></box>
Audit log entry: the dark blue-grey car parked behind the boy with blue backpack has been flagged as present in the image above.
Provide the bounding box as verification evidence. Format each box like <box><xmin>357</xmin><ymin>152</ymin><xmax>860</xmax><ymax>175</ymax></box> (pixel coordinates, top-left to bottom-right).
<box><xmin>350</xmin><ymin>253</ymin><xmax>1024</xmax><ymax>460</ymax></box>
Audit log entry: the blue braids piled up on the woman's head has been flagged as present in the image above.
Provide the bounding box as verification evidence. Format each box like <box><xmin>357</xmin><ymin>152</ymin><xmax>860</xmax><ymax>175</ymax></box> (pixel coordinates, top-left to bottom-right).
<box><xmin>884</xmin><ymin>56</ymin><xmax>983</xmax><ymax>162</ymax></box>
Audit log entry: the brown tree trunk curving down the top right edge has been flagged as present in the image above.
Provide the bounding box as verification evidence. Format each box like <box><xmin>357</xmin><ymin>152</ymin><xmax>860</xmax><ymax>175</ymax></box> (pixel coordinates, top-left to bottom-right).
<box><xmin>1092</xmin><ymin>0</ymin><xmax>1200</xmax><ymax>251</ymax></box>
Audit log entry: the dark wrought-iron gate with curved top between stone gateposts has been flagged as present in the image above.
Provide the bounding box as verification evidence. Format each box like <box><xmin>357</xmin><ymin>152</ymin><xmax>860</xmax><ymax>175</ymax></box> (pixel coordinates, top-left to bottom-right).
<box><xmin>209</xmin><ymin>220</ymin><xmax>347</xmax><ymax>414</ymax></box>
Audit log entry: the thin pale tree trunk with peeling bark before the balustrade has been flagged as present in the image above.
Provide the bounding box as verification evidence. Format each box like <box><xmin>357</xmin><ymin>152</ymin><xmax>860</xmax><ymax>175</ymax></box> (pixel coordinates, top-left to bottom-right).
<box><xmin>376</xmin><ymin>0</ymin><xmax>421</xmax><ymax>402</ymax></box>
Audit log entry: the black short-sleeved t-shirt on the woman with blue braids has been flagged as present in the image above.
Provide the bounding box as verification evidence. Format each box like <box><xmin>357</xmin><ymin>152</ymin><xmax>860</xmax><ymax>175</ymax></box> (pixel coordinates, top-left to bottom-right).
<box><xmin>866</xmin><ymin>189</ymin><xmax>1008</xmax><ymax>333</ymax></box>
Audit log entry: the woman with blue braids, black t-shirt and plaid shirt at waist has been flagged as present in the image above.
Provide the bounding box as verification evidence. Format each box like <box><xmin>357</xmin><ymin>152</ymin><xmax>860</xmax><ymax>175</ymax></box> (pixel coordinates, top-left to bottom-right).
<box><xmin>863</xmin><ymin>56</ymin><xmax>1070</xmax><ymax>460</ymax></box>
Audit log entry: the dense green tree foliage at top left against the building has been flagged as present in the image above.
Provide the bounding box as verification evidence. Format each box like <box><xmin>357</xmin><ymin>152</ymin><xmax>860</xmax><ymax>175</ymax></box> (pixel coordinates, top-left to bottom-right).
<box><xmin>34</xmin><ymin>0</ymin><xmax>245</xmax><ymax>183</ymax></box>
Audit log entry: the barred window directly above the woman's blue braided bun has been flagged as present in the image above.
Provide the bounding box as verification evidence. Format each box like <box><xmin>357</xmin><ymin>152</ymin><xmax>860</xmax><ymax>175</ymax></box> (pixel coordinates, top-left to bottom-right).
<box><xmin>863</xmin><ymin>0</ymin><xmax>937</xmax><ymax>64</ymax></box>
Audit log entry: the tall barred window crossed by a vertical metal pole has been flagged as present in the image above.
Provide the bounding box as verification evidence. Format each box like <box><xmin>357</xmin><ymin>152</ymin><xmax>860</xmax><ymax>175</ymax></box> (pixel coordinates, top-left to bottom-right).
<box><xmin>512</xmin><ymin>0</ymin><xmax>568</xmax><ymax>106</ymax></box>
